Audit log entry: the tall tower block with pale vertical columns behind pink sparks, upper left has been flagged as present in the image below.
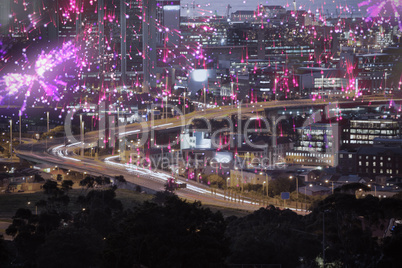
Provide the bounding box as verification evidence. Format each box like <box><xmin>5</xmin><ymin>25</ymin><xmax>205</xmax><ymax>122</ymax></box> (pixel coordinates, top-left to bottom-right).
<box><xmin>47</xmin><ymin>0</ymin><xmax>157</xmax><ymax>90</ymax></box>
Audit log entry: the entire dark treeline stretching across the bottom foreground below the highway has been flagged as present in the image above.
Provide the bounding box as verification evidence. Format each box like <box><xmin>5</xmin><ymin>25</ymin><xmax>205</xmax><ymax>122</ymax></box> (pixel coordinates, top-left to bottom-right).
<box><xmin>0</xmin><ymin>183</ymin><xmax>402</xmax><ymax>268</ymax></box>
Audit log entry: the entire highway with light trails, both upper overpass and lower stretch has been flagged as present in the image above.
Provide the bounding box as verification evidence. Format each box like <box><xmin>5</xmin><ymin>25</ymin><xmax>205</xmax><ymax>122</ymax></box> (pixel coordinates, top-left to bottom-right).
<box><xmin>16</xmin><ymin>95</ymin><xmax>400</xmax><ymax>213</ymax></box>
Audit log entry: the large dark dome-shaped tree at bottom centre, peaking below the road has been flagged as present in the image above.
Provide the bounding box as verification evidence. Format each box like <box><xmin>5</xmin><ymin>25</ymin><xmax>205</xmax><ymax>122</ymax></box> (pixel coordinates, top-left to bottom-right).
<box><xmin>104</xmin><ymin>196</ymin><xmax>228</xmax><ymax>267</ymax></box>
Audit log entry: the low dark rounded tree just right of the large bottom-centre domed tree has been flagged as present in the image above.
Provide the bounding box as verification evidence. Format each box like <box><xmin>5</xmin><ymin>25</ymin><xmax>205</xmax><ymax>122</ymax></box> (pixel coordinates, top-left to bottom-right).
<box><xmin>226</xmin><ymin>206</ymin><xmax>321</xmax><ymax>267</ymax></box>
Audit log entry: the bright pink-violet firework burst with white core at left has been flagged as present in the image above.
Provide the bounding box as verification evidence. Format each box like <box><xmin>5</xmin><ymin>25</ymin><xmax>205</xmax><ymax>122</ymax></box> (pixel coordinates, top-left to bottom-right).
<box><xmin>0</xmin><ymin>42</ymin><xmax>77</xmax><ymax>110</ymax></box>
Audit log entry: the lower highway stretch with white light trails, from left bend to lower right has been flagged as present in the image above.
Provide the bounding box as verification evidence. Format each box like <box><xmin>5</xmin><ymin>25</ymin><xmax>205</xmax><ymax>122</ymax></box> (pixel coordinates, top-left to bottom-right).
<box><xmin>17</xmin><ymin>139</ymin><xmax>268</xmax><ymax>213</ymax></box>
